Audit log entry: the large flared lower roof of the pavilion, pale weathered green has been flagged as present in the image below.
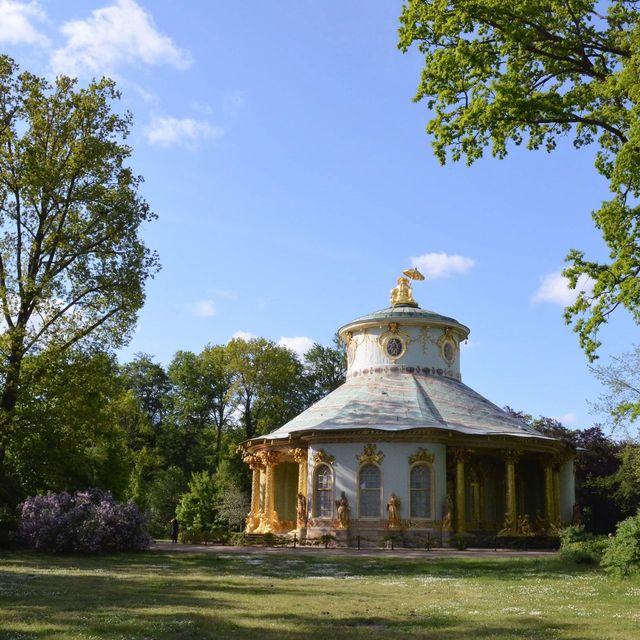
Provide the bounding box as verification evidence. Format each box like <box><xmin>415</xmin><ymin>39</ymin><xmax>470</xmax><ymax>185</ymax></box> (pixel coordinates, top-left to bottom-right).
<box><xmin>263</xmin><ymin>372</ymin><xmax>549</xmax><ymax>440</ymax></box>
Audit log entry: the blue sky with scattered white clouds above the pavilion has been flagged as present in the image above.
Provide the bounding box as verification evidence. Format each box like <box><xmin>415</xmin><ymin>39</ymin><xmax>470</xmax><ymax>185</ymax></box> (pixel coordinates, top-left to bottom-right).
<box><xmin>0</xmin><ymin>0</ymin><xmax>638</xmax><ymax>436</ymax></box>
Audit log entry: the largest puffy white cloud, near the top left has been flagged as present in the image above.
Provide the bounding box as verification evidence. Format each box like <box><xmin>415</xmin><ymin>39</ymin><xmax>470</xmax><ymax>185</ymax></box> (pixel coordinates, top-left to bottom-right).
<box><xmin>51</xmin><ymin>0</ymin><xmax>190</xmax><ymax>76</ymax></box>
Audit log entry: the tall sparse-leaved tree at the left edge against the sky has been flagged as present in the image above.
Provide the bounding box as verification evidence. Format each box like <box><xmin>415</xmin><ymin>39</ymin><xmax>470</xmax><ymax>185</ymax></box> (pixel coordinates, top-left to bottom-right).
<box><xmin>0</xmin><ymin>56</ymin><xmax>157</xmax><ymax>498</ymax></box>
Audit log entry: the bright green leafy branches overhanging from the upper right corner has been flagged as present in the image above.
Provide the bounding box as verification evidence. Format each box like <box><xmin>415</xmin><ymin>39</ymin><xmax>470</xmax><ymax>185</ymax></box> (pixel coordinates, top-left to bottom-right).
<box><xmin>399</xmin><ymin>0</ymin><xmax>640</xmax><ymax>360</ymax></box>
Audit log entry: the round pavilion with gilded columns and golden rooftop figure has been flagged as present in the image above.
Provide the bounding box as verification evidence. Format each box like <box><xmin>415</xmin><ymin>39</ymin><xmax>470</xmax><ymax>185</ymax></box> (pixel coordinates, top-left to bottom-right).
<box><xmin>242</xmin><ymin>269</ymin><xmax>575</xmax><ymax>544</ymax></box>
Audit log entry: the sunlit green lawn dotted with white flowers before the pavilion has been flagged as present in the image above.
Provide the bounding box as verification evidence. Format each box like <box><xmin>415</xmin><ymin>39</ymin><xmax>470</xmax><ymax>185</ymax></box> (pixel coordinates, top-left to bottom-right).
<box><xmin>0</xmin><ymin>551</ymin><xmax>640</xmax><ymax>640</ymax></box>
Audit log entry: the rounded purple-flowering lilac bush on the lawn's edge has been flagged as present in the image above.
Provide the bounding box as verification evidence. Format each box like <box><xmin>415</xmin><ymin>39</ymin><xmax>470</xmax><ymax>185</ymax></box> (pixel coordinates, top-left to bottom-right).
<box><xmin>18</xmin><ymin>489</ymin><xmax>151</xmax><ymax>553</ymax></box>
